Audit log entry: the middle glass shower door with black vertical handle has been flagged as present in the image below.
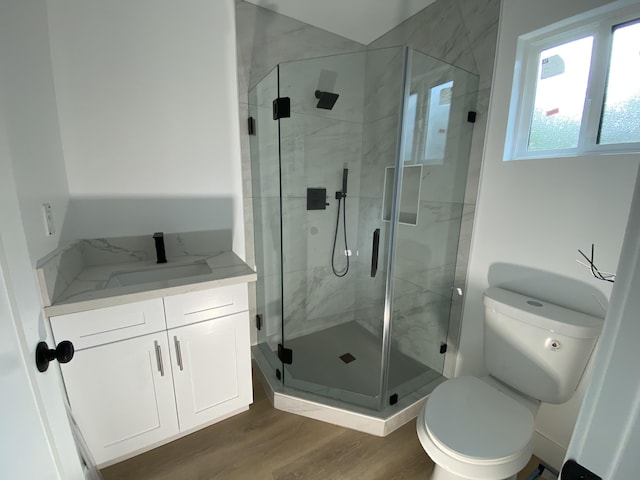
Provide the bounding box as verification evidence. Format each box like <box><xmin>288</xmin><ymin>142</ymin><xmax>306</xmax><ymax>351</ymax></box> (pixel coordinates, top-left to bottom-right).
<box><xmin>279</xmin><ymin>49</ymin><xmax>402</xmax><ymax>409</ymax></box>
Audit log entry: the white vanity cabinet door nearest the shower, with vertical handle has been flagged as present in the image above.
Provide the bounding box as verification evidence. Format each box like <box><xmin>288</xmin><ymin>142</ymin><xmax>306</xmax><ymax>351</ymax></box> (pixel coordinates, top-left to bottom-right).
<box><xmin>169</xmin><ymin>312</ymin><xmax>253</xmax><ymax>431</ymax></box>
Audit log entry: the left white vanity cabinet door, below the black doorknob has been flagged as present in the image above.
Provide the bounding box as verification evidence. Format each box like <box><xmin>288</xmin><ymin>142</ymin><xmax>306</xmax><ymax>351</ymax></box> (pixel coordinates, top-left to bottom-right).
<box><xmin>61</xmin><ymin>332</ymin><xmax>178</xmax><ymax>465</ymax></box>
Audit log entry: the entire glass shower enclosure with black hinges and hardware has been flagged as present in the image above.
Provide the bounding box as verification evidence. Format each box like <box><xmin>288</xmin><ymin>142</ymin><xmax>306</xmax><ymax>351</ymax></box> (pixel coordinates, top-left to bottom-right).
<box><xmin>249</xmin><ymin>47</ymin><xmax>478</xmax><ymax>411</ymax></box>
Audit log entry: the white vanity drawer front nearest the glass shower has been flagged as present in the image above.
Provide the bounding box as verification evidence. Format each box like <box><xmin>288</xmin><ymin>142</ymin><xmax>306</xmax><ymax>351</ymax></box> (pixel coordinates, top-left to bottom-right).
<box><xmin>164</xmin><ymin>283</ymin><xmax>249</xmax><ymax>328</ymax></box>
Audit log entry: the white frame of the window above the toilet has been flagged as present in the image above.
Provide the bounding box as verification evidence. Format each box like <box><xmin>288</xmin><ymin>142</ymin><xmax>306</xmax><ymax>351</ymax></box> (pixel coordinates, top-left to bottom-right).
<box><xmin>503</xmin><ymin>5</ymin><xmax>640</xmax><ymax>161</ymax></box>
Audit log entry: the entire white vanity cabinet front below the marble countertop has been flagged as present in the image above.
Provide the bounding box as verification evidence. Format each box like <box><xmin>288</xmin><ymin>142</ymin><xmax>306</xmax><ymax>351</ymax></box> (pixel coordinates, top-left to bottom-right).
<box><xmin>50</xmin><ymin>284</ymin><xmax>252</xmax><ymax>467</ymax></box>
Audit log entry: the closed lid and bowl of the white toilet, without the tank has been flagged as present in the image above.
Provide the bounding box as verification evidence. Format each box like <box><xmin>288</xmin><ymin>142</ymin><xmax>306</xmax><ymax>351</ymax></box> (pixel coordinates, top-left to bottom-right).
<box><xmin>417</xmin><ymin>377</ymin><xmax>534</xmax><ymax>479</ymax></box>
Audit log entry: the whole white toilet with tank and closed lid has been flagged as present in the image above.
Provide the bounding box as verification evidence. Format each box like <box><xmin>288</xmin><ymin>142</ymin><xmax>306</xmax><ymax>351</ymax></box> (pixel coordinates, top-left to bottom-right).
<box><xmin>417</xmin><ymin>287</ymin><xmax>603</xmax><ymax>480</ymax></box>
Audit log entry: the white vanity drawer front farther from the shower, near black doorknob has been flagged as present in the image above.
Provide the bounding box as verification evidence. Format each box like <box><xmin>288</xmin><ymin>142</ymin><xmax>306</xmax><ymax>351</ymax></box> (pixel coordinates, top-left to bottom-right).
<box><xmin>51</xmin><ymin>298</ymin><xmax>166</xmax><ymax>350</ymax></box>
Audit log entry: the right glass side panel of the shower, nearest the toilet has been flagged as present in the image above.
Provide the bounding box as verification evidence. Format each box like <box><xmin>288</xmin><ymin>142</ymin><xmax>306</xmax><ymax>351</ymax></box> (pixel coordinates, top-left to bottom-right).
<box><xmin>388</xmin><ymin>51</ymin><xmax>478</xmax><ymax>397</ymax></box>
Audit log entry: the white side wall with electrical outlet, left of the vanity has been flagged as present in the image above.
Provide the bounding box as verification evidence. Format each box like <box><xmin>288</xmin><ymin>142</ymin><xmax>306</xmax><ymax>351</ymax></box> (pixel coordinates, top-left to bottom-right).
<box><xmin>0</xmin><ymin>0</ymin><xmax>68</xmax><ymax>264</ymax></box>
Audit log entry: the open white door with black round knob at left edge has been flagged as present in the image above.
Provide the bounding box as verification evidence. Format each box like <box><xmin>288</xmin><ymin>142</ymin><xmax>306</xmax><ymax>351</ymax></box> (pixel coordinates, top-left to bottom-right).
<box><xmin>0</xmin><ymin>116</ymin><xmax>83</xmax><ymax>480</ymax></box>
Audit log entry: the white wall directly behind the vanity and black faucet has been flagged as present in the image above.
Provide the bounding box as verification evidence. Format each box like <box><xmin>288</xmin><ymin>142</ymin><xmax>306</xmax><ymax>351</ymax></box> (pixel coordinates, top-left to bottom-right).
<box><xmin>48</xmin><ymin>0</ymin><xmax>244</xmax><ymax>256</ymax></box>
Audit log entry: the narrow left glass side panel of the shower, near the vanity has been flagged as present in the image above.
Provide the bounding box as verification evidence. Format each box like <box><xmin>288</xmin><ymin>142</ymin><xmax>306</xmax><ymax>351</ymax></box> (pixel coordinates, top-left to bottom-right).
<box><xmin>249</xmin><ymin>67</ymin><xmax>282</xmax><ymax>370</ymax></box>
